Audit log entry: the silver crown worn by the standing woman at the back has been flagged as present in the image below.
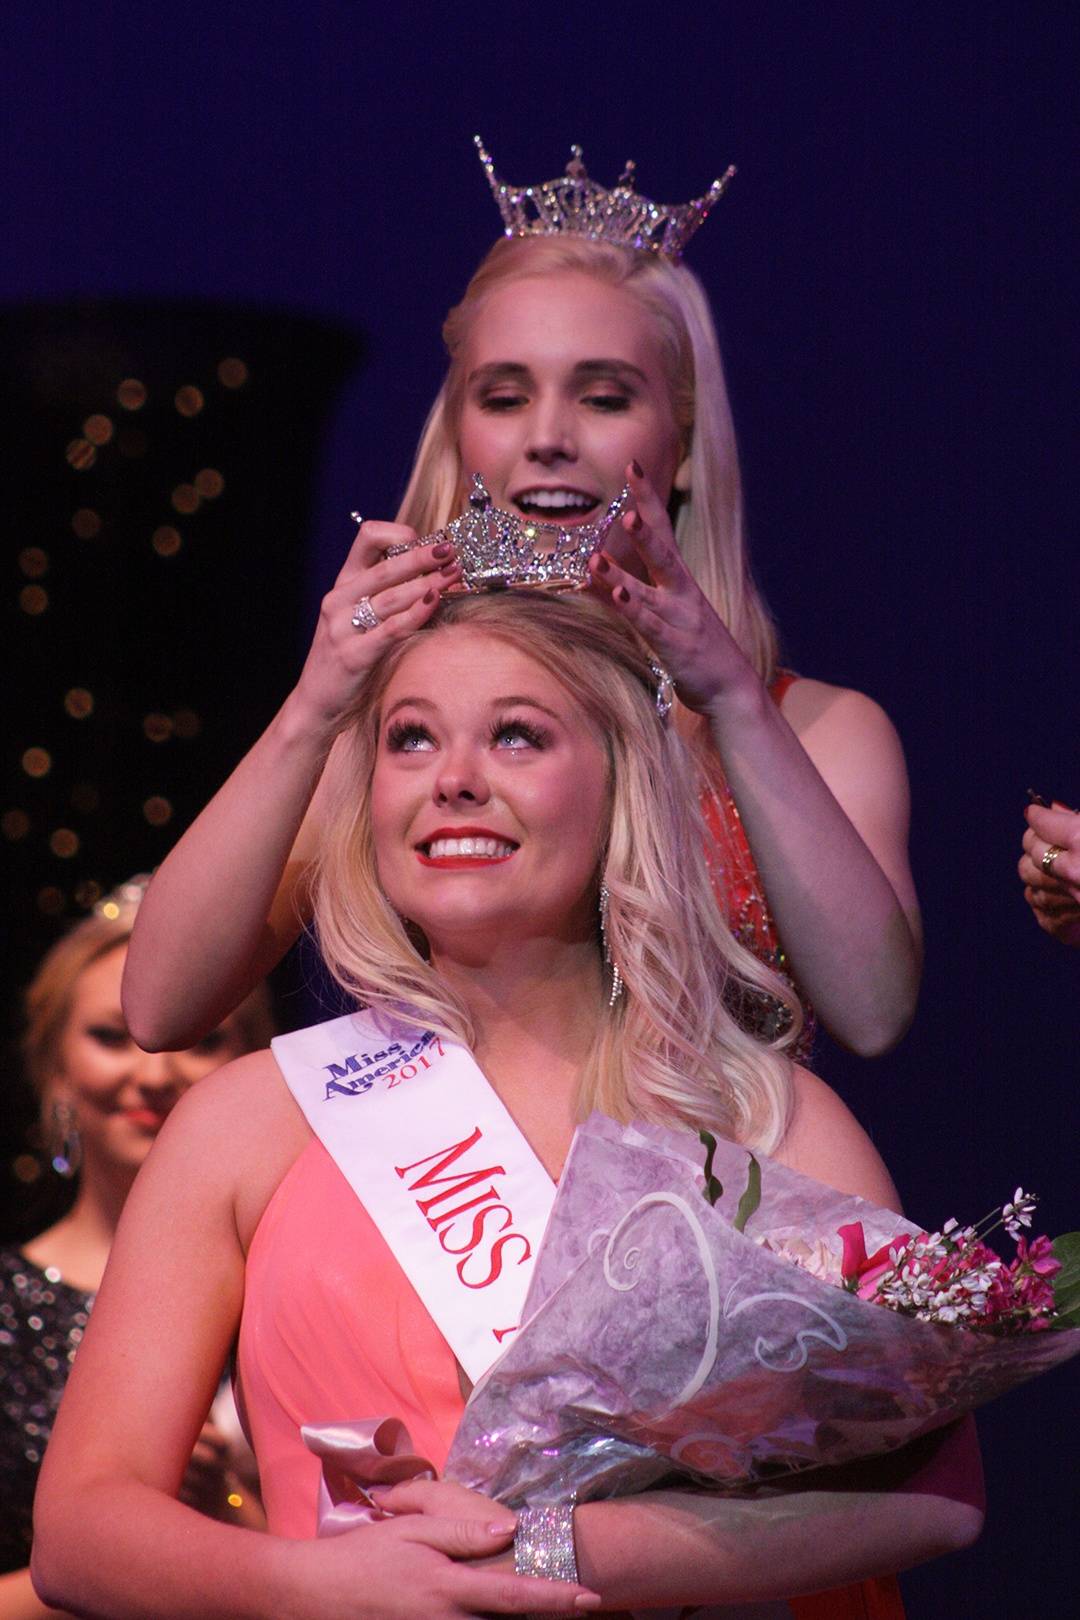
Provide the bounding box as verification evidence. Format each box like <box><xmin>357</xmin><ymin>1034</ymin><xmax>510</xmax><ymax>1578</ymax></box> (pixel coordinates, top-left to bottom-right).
<box><xmin>473</xmin><ymin>134</ymin><xmax>735</xmax><ymax>264</ymax></box>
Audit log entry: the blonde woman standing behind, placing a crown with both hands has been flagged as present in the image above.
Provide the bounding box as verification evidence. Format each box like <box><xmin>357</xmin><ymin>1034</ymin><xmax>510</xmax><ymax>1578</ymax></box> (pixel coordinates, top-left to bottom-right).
<box><xmin>125</xmin><ymin>152</ymin><xmax>921</xmax><ymax>1056</ymax></box>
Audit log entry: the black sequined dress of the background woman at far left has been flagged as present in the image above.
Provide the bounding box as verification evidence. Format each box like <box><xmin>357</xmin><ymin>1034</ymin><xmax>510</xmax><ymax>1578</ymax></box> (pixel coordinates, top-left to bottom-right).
<box><xmin>0</xmin><ymin>1249</ymin><xmax>94</xmax><ymax>1575</ymax></box>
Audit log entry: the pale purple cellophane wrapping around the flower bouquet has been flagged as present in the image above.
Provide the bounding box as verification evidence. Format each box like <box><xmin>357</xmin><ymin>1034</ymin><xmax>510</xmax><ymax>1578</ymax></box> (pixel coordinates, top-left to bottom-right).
<box><xmin>447</xmin><ymin>1115</ymin><xmax>1080</xmax><ymax>1508</ymax></box>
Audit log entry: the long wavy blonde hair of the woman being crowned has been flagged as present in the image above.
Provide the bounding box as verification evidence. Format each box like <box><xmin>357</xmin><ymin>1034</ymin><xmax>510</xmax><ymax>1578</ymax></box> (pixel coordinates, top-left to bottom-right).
<box><xmin>307</xmin><ymin>591</ymin><xmax>801</xmax><ymax>1152</ymax></box>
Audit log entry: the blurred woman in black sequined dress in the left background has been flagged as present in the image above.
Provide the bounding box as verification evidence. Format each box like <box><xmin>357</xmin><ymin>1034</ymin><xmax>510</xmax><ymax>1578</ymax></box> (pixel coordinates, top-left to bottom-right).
<box><xmin>0</xmin><ymin>878</ymin><xmax>274</xmax><ymax>1620</ymax></box>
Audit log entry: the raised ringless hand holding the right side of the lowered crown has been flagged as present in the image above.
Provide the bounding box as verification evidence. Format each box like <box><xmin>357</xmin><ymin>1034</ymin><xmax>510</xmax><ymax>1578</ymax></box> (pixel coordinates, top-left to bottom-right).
<box><xmin>589</xmin><ymin>462</ymin><xmax>755</xmax><ymax>711</ymax></box>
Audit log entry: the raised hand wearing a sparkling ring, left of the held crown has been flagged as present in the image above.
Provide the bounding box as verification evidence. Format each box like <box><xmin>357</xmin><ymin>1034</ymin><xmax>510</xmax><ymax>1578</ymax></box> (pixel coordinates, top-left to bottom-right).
<box><xmin>296</xmin><ymin>520</ymin><xmax>460</xmax><ymax>732</ymax></box>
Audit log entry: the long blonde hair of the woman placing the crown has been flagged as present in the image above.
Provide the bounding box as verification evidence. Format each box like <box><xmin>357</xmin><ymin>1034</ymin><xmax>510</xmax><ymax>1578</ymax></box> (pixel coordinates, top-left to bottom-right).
<box><xmin>398</xmin><ymin>237</ymin><xmax>777</xmax><ymax>684</ymax></box>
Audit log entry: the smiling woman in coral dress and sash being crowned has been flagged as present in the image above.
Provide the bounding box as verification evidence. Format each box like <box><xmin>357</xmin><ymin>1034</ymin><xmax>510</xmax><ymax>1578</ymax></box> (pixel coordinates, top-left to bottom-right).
<box><xmin>34</xmin><ymin>582</ymin><xmax>981</xmax><ymax>1620</ymax></box>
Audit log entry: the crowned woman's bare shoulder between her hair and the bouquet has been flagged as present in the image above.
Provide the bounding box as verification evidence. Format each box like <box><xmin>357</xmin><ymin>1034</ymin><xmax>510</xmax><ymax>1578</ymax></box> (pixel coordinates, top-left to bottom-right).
<box><xmin>774</xmin><ymin>1068</ymin><xmax>900</xmax><ymax>1210</ymax></box>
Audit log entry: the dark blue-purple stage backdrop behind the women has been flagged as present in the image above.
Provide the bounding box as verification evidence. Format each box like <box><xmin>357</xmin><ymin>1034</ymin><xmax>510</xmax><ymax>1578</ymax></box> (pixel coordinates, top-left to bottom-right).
<box><xmin>0</xmin><ymin>0</ymin><xmax>1080</xmax><ymax>1620</ymax></box>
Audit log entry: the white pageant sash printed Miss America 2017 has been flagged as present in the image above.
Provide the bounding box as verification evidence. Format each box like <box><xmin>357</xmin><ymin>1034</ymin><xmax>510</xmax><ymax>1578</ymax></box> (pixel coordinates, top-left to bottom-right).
<box><xmin>270</xmin><ymin>1013</ymin><xmax>555</xmax><ymax>1382</ymax></box>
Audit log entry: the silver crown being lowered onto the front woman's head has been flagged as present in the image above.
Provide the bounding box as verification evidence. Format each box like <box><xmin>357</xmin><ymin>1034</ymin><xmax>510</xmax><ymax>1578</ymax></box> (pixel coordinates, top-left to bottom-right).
<box><xmin>387</xmin><ymin>473</ymin><xmax>630</xmax><ymax>591</ymax></box>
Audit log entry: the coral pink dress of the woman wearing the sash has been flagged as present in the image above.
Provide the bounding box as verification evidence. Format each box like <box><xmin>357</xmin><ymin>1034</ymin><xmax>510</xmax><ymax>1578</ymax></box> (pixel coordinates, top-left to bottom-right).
<box><xmin>236</xmin><ymin>1137</ymin><xmax>904</xmax><ymax>1620</ymax></box>
